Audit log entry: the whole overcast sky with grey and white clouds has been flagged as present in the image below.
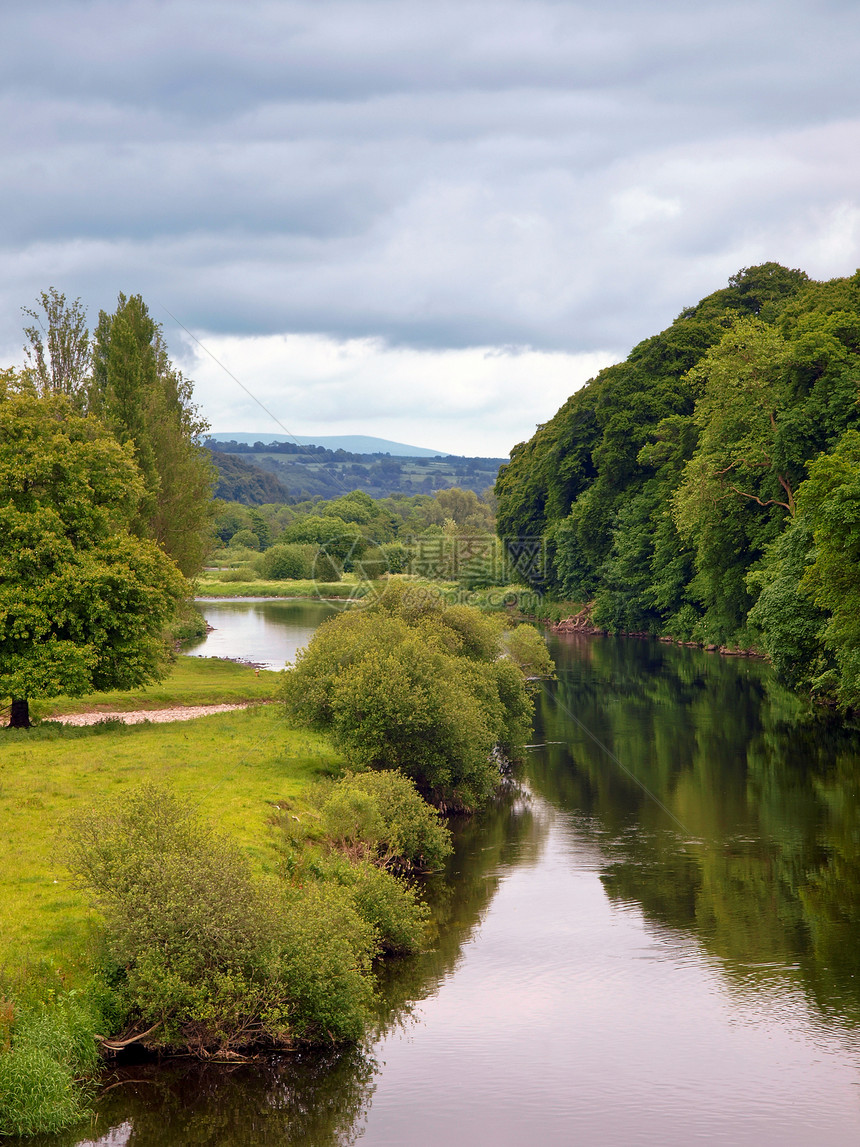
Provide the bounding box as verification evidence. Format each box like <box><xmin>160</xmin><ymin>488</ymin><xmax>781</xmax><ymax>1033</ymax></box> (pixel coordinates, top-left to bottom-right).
<box><xmin>0</xmin><ymin>0</ymin><xmax>860</xmax><ymax>454</ymax></box>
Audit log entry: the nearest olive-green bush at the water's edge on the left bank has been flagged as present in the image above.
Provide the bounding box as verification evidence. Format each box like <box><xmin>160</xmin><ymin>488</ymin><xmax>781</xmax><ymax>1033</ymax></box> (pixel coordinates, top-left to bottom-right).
<box><xmin>69</xmin><ymin>786</ymin><xmax>385</xmax><ymax>1050</ymax></box>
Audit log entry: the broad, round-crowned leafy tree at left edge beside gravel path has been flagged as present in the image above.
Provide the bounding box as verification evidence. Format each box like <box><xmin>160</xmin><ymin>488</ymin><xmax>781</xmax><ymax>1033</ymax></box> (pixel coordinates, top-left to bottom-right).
<box><xmin>0</xmin><ymin>385</ymin><xmax>186</xmax><ymax>727</ymax></box>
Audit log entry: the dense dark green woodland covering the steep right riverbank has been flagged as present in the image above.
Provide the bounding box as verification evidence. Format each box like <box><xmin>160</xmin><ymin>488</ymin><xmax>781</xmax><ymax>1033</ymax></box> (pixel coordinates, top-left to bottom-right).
<box><xmin>495</xmin><ymin>263</ymin><xmax>860</xmax><ymax>708</ymax></box>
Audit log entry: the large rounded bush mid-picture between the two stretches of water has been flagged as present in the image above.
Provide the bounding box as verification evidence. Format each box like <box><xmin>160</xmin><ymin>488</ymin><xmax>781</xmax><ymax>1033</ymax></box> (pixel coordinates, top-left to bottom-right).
<box><xmin>284</xmin><ymin>583</ymin><xmax>541</xmax><ymax>807</ymax></box>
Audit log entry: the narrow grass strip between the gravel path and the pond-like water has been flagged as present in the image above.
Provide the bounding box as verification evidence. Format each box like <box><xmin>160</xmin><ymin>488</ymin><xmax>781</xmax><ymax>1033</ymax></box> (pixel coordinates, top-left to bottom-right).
<box><xmin>30</xmin><ymin>657</ymin><xmax>280</xmax><ymax>718</ymax></box>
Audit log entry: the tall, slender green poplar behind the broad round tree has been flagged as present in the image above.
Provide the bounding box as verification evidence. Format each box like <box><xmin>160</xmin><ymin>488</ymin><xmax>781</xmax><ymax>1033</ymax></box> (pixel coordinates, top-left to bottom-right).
<box><xmin>89</xmin><ymin>294</ymin><xmax>216</xmax><ymax>576</ymax></box>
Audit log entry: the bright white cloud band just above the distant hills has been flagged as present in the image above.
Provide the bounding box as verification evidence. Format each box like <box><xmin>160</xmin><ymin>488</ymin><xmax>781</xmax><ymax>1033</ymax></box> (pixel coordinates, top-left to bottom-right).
<box><xmin>181</xmin><ymin>335</ymin><xmax>615</xmax><ymax>458</ymax></box>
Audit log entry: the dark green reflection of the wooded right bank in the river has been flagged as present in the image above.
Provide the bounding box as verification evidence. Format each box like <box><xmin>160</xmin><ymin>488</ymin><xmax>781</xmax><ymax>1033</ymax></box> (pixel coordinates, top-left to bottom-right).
<box><xmin>529</xmin><ymin>639</ymin><xmax>860</xmax><ymax>1025</ymax></box>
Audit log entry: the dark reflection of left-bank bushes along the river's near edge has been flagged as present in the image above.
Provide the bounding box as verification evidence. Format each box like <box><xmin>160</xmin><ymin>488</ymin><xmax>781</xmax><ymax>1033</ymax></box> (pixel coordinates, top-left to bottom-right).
<box><xmin>48</xmin><ymin>788</ymin><xmax>545</xmax><ymax>1147</ymax></box>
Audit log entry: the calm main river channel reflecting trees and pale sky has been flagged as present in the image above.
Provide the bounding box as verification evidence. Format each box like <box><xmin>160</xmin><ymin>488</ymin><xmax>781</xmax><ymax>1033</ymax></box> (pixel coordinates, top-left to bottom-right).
<box><xmin>52</xmin><ymin>603</ymin><xmax>860</xmax><ymax>1147</ymax></box>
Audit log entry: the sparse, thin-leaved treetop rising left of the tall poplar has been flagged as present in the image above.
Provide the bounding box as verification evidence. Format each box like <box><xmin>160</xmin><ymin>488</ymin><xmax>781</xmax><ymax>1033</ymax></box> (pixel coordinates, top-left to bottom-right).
<box><xmin>23</xmin><ymin>287</ymin><xmax>92</xmax><ymax>411</ymax></box>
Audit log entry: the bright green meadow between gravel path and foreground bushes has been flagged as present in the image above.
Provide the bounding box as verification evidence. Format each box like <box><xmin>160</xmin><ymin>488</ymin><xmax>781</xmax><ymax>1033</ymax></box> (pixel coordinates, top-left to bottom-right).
<box><xmin>0</xmin><ymin>701</ymin><xmax>342</xmax><ymax>985</ymax></box>
